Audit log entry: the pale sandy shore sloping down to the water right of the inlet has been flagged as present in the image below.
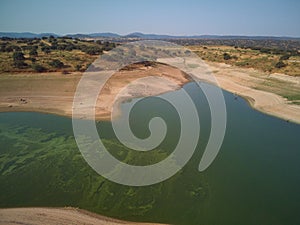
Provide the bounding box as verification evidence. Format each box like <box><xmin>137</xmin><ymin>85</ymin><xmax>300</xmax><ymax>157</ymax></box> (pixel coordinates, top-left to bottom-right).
<box><xmin>209</xmin><ymin>63</ymin><xmax>300</xmax><ymax>123</ymax></box>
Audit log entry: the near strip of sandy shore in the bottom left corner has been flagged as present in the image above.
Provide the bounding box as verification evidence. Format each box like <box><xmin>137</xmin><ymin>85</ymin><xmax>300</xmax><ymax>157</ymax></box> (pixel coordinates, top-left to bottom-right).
<box><xmin>0</xmin><ymin>207</ymin><xmax>168</xmax><ymax>225</ymax></box>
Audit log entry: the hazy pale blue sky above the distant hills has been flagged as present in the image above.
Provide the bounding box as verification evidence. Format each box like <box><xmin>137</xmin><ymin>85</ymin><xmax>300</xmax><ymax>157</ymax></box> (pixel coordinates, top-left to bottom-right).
<box><xmin>0</xmin><ymin>0</ymin><xmax>300</xmax><ymax>37</ymax></box>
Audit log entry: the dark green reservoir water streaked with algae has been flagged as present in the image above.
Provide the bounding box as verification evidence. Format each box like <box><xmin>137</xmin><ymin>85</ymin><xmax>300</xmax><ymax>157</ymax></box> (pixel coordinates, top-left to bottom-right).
<box><xmin>0</xmin><ymin>83</ymin><xmax>300</xmax><ymax>225</ymax></box>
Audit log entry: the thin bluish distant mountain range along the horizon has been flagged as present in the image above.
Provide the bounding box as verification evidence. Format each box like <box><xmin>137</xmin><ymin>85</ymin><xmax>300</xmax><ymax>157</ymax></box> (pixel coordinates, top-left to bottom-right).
<box><xmin>0</xmin><ymin>32</ymin><xmax>300</xmax><ymax>40</ymax></box>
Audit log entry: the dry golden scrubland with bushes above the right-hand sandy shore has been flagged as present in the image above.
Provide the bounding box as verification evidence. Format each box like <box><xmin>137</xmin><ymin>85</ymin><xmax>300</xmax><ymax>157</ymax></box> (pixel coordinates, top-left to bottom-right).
<box><xmin>188</xmin><ymin>45</ymin><xmax>300</xmax><ymax>76</ymax></box>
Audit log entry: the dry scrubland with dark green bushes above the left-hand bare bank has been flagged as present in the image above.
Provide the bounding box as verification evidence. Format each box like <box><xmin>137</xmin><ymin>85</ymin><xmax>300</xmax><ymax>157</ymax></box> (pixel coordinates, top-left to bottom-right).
<box><xmin>0</xmin><ymin>36</ymin><xmax>115</xmax><ymax>73</ymax></box>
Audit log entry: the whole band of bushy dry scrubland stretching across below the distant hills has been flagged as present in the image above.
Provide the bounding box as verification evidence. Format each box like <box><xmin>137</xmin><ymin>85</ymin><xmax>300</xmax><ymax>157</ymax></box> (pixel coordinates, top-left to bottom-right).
<box><xmin>0</xmin><ymin>36</ymin><xmax>300</xmax><ymax>76</ymax></box>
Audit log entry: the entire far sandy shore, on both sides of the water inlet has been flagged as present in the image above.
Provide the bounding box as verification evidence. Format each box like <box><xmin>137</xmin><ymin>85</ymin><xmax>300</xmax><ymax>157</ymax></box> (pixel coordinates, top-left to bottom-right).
<box><xmin>0</xmin><ymin>62</ymin><xmax>300</xmax><ymax>123</ymax></box>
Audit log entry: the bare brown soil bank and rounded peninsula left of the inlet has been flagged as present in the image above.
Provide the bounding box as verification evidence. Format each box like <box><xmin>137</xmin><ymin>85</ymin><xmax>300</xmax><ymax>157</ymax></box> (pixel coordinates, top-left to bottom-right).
<box><xmin>0</xmin><ymin>65</ymin><xmax>188</xmax><ymax>119</ymax></box>
